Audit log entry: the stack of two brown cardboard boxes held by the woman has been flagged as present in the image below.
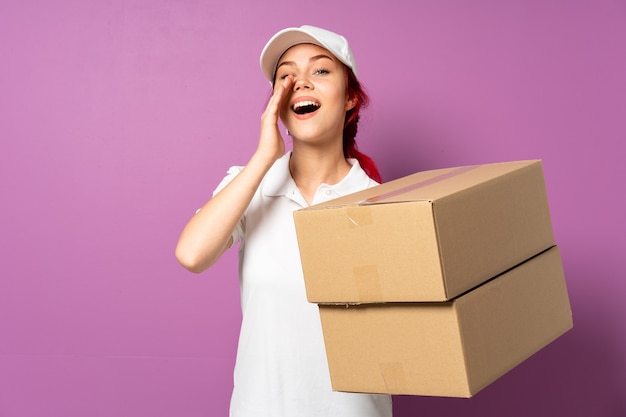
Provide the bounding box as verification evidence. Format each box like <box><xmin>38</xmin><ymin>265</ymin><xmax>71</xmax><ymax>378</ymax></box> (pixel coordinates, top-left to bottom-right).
<box><xmin>294</xmin><ymin>161</ymin><xmax>572</xmax><ymax>397</ymax></box>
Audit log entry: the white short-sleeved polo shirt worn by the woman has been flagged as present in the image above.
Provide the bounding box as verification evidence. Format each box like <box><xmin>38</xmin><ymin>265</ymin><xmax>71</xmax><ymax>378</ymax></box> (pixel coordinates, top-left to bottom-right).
<box><xmin>215</xmin><ymin>152</ymin><xmax>392</xmax><ymax>417</ymax></box>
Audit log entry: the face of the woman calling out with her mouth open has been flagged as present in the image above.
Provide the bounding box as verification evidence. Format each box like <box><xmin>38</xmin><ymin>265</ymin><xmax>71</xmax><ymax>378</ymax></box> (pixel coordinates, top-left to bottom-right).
<box><xmin>274</xmin><ymin>44</ymin><xmax>353</xmax><ymax>142</ymax></box>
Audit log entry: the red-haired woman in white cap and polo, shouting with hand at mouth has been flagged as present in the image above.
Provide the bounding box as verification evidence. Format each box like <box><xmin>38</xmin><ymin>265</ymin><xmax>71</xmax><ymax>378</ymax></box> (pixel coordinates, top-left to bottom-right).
<box><xmin>176</xmin><ymin>26</ymin><xmax>392</xmax><ymax>417</ymax></box>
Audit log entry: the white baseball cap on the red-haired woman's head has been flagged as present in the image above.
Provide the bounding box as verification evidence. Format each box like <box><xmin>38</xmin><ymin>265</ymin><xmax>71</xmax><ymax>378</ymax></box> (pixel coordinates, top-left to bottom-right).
<box><xmin>260</xmin><ymin>25</ymin><xmax>357</xmax><ymax>82</ymax></box>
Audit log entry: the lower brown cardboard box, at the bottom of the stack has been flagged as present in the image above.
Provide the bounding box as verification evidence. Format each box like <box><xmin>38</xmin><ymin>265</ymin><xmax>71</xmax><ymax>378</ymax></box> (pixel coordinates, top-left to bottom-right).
<box><xmin>319</xmin><ymin>246</ymin><xmax>572</xmax><ymax>397</ymax></box>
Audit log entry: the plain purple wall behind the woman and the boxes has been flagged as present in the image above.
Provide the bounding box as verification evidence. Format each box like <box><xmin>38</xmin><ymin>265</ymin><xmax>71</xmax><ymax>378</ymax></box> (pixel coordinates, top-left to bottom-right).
<box><xmin>0</xmin><ymin>0</ymin><xmax>626</xmax><ymax>417</ymax></box>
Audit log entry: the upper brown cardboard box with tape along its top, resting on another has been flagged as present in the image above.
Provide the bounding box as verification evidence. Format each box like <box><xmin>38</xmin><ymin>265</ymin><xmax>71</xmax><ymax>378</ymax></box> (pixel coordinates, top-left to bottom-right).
<box><xmin>294</xmin><ymin>160</ymin><xmax>554</xmax><ymax>303</ymax></box>
